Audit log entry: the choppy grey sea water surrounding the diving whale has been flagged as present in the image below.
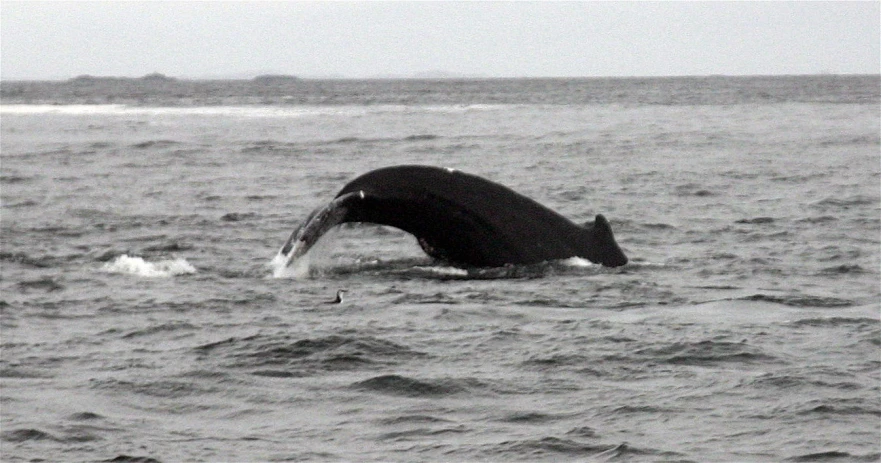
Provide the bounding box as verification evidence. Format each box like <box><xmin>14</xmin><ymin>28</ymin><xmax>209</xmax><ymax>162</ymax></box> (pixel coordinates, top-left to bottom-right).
<box><xmin>0</xmin><ymin>76</ymin><xmax>881</xmax><ymax>462</ymax></box>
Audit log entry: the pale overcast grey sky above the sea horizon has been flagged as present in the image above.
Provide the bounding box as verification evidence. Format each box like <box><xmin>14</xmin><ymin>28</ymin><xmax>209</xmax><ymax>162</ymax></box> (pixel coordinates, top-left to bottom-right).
<box><xmin>0</xmin><ymin>0</ymin><xmax>881</xmax><ymax>79</ymax></box>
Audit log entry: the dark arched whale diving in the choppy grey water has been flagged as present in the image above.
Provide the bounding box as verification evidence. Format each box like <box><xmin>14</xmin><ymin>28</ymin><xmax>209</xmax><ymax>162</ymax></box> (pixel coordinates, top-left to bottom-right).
<box><xmin>276</xmin><ymin>165</ymin><xmax>627</xmax><ymax>268</ymax></box>
